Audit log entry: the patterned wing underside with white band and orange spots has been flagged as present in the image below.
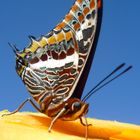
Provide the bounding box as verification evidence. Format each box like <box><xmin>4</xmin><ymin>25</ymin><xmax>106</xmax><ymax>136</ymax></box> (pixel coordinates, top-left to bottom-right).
<box><xmin>17</xmin><ymin>0</ymin><xmax>101</xmax><ymax>108</ymax></box>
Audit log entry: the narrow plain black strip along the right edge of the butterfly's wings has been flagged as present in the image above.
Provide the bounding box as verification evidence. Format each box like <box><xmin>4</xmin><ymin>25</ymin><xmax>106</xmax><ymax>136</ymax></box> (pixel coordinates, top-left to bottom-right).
<box><xmin>72</xmin><ymin>0</ymin><xmax>103</xmax><ymax>99</ymax></box>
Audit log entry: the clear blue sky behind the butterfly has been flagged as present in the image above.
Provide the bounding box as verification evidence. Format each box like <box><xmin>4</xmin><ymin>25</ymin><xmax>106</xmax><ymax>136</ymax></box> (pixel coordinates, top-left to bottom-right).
<box><xmin>0</xmin><ymin>0</ymin><xmax>140</xmax><ymax>125</ymax></box>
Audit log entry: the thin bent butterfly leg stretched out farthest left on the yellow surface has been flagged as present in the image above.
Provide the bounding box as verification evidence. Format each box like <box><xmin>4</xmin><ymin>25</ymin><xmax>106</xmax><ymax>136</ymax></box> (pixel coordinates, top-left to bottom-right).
<box><xmin>2</xmin><ymin>98</ymin><xmax>41</xmax><ymax>117</ymax></box>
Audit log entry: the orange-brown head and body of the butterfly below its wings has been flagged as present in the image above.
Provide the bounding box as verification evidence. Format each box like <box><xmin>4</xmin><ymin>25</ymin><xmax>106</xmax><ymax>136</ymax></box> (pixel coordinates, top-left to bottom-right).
<box><xmin>40</xmin><ymin>98</ymin><xmax>89</xmax><ymax>121</ymax></box>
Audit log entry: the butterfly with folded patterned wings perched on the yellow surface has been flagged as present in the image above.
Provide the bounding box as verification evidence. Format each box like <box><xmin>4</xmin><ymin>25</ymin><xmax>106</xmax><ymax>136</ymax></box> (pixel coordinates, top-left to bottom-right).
<box><xmin>4</xmin><ymin>0</ymin><xmax>103</xmax><ymax>136</ymax></box>
